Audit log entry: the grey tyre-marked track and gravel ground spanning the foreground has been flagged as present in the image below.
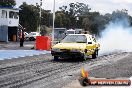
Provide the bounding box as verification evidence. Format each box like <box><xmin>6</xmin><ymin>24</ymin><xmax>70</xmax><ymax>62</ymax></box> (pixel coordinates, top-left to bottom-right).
<box><xmin>0</xmin><ymin>52</ymin><xmax>132</xmax><ymax>88</ymax></box>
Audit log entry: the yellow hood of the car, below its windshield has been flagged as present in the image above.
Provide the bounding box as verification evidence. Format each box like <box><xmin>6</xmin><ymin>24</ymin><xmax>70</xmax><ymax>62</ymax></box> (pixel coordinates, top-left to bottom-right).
<box><xmin>52</xmin><ymin>43</ymin><xmax>86</xmax><ymax>49</ymax></box>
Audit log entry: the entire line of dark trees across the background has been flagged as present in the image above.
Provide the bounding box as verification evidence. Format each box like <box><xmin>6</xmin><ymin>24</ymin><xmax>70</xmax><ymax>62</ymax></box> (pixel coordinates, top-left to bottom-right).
<box><xmin>0</xmin><ymin>0</ymin><xmax>132</xmax><ymax>35</ymax></box>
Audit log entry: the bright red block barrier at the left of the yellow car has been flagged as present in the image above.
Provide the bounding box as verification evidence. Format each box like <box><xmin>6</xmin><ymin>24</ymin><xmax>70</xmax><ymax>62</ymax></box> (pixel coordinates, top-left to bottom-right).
<box><xmin>36</xmin><ymin>36</ymin><xmax>51</xmax><ymax>50</ymax></box>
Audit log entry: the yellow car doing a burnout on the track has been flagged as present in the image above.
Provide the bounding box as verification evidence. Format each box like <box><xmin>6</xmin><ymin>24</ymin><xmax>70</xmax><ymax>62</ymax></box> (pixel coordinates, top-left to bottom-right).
<box><xmin>51</xmin><ymin>34</ymin><xmax>100</xmax><ymax>60</ymax></box>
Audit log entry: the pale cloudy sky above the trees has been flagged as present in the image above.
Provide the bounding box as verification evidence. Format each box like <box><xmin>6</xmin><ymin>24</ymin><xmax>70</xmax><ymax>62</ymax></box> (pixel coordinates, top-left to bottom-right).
<box><xmin>16</xmin><ymin>0</ymin><xmax>132</xmax><ymax>16</ymax></box>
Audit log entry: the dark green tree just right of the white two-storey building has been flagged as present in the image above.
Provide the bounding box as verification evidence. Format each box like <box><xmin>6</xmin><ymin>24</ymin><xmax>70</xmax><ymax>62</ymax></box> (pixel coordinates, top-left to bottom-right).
<box><xmin>20</xmin><ymin>2</ymin><xmax>39</xmax><ymax>32</ymax></box>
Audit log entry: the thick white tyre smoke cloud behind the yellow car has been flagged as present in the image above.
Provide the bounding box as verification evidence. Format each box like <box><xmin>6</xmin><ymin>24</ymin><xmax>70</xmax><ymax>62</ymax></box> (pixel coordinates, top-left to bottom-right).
<box><xmin>98</xmin><ymin>19</ymin><xmax>132</xmax><ymax>54</ymax></box>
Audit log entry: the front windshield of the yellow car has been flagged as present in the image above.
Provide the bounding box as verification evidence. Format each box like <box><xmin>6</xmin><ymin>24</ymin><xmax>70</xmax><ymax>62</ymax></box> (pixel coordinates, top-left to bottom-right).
<box><xmin>62</xmin><ymin>35</ymin><xmax>87</xmax><ymax>43</ymax></box>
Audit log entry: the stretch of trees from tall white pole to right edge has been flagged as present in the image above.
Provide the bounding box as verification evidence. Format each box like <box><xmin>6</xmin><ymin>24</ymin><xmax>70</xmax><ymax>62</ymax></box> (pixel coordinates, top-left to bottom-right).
<box><xmin>55</xmin><ymin>2</ymin><xmax>132</xmax><ymax>36</ymax></box>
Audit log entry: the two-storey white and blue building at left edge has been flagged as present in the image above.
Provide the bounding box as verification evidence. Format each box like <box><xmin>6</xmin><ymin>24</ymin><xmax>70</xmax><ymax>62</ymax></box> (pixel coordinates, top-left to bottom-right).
<box><xmin>0</xmin><ymin>7</ymin><xmax>20</xmax><ymax>42</ymax></box>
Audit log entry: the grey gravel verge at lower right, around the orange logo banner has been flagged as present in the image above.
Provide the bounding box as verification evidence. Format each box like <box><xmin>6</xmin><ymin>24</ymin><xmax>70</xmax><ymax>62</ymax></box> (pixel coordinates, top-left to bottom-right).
<box><xmin>63</xmin><ymin>53</ymin><xmax>132</xmax><ymax>88</ymax></box>
